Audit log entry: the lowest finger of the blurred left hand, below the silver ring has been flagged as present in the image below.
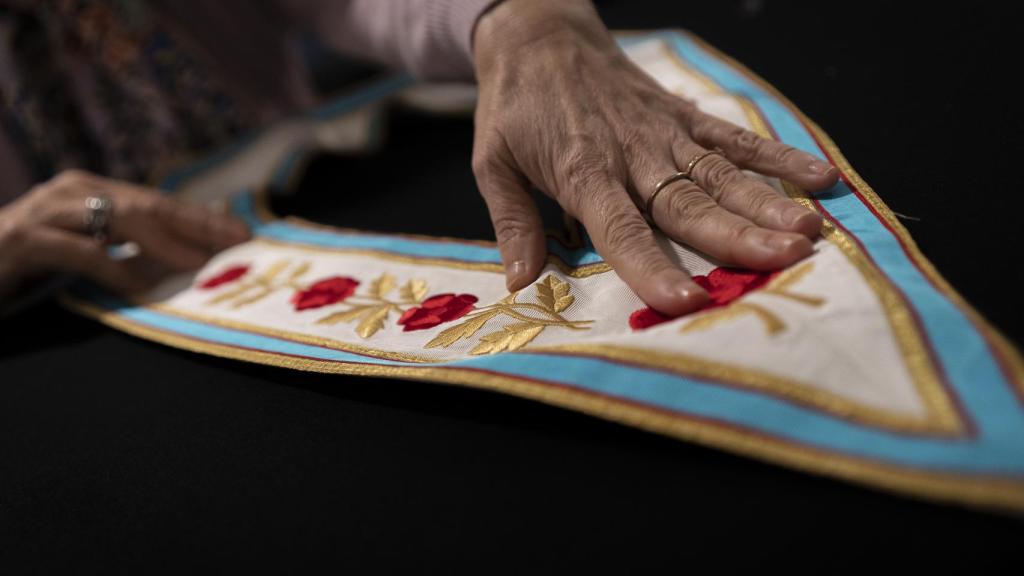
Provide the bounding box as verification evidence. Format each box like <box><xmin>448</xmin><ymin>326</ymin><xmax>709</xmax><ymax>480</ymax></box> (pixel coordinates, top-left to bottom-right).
<box><xmin>24</xmin><ymin>227</ymin><xmax>150</xmax><ymax>293</ymax></box>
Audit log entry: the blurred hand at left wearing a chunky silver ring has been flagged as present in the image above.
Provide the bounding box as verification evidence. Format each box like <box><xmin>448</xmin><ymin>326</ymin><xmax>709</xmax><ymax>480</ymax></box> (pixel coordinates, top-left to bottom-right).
<box><xmin>0</xmin><ymin>170</ymin><xmax>249</xmax><ymax>297</ymax></box>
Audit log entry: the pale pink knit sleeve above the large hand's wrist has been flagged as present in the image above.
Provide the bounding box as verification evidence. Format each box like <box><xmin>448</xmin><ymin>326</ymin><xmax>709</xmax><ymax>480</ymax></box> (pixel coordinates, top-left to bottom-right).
<box><xmin>284</xmin><ymin>0</ymin><xmax>500</xmax><ymax>80</ymax></box>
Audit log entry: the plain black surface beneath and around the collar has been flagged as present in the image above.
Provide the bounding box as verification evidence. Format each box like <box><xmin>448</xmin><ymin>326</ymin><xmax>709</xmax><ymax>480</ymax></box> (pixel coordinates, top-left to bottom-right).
<box><xmin>0</xmin><ymin>0</ymin><xmax>1024</xmax><ymax>573</ymax></box>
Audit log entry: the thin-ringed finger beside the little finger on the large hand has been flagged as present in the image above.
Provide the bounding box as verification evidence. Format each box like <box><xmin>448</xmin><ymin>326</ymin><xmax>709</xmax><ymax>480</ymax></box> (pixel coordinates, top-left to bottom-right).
<box><xmin>673</xmin><ymin>140</ymin><xmax>821</xmax><ymax>238</ymax></box>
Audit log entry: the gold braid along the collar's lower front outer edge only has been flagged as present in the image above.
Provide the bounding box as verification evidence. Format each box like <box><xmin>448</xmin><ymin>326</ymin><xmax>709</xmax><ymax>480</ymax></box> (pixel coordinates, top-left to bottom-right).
<box><xmin>61</xmin><ymin>295</ymin><xmax>1024</xmax><ymax>511</ymax></box>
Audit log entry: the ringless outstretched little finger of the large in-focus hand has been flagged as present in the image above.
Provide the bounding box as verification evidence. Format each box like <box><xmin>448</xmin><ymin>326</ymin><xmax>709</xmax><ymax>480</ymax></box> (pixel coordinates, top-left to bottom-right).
<box><xmin>690</xmin><ymin>112</ymin><xmax>839</xmax><ymax>192</ymax></box>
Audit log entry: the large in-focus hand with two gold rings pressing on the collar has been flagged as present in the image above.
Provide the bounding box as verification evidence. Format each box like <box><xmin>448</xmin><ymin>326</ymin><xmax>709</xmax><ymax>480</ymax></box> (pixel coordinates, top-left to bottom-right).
<box><xmin>473</xmin><ymin>0</ymin><xmax>838</xmax><ymax>315</ymax></box>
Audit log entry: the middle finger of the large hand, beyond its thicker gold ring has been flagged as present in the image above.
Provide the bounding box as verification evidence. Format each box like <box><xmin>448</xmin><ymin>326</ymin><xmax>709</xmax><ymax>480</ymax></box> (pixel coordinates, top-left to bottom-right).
<box><xmin>652</xmin><ymin>176</ymin><xmax>814</xmax><ymax>270</ymax></box>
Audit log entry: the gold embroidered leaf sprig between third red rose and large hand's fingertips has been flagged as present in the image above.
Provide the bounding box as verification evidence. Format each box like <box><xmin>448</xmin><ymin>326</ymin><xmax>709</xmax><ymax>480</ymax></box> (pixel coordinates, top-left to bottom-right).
<box><xmin>424</xmin><ymin>275</ymin><xmax>594</xmax><ymax>356</ymax></box>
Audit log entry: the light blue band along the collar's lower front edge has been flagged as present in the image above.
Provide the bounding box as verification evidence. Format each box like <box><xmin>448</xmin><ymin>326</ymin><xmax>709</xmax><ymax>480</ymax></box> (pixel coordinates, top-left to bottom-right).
<box><xmin>79</xmin><ymin>286</ymin><xmax>1024</xmax><ymax>475</ymax></box>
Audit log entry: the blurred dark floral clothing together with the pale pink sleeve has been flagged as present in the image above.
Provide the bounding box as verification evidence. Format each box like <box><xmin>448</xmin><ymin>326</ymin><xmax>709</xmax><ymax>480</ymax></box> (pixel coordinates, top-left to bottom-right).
<box><xmin>0</xmin><ymin>0</ymin><xmax>494</xmax><ymax>204</ymax></box>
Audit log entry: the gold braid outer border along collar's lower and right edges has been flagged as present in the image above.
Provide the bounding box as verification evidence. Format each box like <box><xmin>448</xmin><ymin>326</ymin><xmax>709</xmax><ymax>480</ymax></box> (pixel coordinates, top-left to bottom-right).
<box><xmin>62</xmin><ymin>37</ymin><xmax>1024</xmax><ymax>510</ymax></box>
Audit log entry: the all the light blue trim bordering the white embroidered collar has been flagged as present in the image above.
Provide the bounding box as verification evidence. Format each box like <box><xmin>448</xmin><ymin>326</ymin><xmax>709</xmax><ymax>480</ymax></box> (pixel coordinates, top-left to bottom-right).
<box><xmin>81</xmin><ymin>33</ymin><xmax>1024</xmax><ymax>478</ymax></box>
